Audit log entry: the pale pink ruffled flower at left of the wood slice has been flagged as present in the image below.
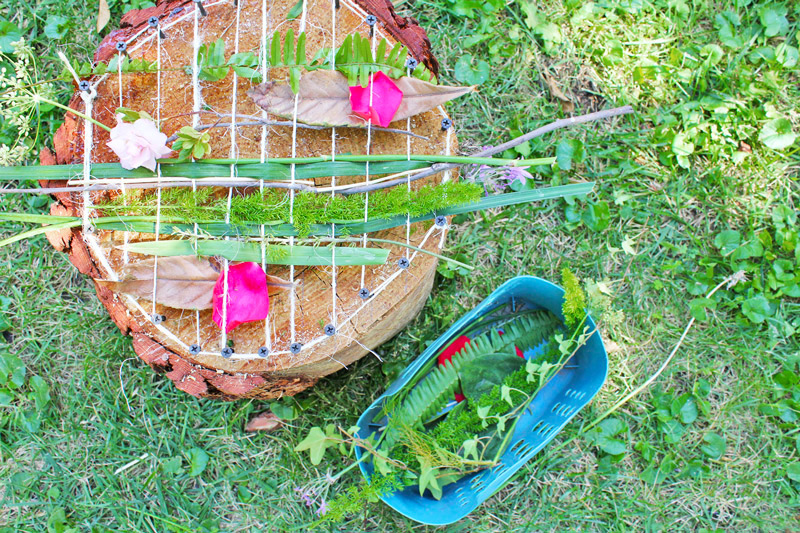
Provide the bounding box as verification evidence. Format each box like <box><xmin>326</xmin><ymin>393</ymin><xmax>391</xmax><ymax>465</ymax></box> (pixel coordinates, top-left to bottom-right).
<box><xmin>107</xmin><ymin>115</ymin><xmax>172</xmax><ymax>171</ymax></box>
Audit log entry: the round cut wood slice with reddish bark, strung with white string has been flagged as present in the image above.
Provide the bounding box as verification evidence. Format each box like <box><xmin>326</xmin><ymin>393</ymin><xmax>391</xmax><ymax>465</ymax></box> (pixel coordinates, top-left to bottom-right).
<box><xmin>40</xmin><ymin>0</ymin><xmax>458</xmax><ymax>400</ymax></box>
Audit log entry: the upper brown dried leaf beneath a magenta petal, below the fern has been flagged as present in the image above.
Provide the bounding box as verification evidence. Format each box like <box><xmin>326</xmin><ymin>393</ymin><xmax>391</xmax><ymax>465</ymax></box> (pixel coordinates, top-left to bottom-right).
<box><xmin>247</xmin><ymin>70</ymin><xmax>474</xmax><ymax>126</ymax></box>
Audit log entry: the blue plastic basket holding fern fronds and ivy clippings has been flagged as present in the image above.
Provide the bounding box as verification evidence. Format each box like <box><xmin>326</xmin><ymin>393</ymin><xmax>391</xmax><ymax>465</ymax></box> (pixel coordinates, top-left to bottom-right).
<box><xmin>356</xmin><ymin>276</ymin><xmax>608</xmax><ymax>526</ymax></box>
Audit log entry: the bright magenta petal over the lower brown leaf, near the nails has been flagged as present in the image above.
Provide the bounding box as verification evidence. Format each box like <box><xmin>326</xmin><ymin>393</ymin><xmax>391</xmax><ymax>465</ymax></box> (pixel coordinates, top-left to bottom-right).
<box><xmin>212</xmin><ymin>263</ymin><xmax>269</xmax><ymax>333</ymax></box>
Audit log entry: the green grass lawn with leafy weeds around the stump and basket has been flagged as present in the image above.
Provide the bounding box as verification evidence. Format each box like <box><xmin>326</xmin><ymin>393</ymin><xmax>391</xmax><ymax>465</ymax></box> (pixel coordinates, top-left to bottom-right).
<box><xmin>0</xmin><ymin>0</ymin><xmax>800</xmax><ymax>531</ymax></box>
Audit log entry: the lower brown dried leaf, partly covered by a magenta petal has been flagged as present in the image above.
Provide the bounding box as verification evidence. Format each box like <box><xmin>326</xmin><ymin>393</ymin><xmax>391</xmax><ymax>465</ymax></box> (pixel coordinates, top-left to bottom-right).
<box><xmin>98</xmin><ymin>255</ymin><xmax>294</xmax><ymax>310</ymax></box>
